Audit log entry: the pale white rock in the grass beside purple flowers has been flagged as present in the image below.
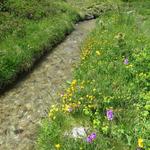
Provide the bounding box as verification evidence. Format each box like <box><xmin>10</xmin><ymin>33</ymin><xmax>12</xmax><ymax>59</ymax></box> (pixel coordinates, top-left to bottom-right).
<box><xmin>72</xmin><ymin>127</ymin><xmax>86</xmax><ymax>138</ymax></box>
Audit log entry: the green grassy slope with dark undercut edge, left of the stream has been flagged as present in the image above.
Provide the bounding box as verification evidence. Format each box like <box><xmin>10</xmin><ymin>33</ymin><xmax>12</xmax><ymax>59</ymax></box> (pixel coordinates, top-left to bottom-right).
<box><xmin>0</xmin><ymin>0</ymin><xmax>79</xmax><ymax>89</ymax></box>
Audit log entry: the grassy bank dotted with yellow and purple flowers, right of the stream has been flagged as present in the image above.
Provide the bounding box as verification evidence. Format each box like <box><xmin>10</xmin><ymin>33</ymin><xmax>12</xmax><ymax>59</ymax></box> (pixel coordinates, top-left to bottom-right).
<box><xmin>37</xmin><ymin>1</ymin><xmax>150</xmax><ymax>150</ymax></box>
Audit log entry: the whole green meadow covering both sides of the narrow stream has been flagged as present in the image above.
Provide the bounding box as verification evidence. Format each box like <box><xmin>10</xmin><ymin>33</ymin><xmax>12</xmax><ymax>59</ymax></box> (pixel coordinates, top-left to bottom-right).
<box><xmin>0</xmin><ymin>0</ymin><xmax>150</xmax><ymax>150</ymax></box>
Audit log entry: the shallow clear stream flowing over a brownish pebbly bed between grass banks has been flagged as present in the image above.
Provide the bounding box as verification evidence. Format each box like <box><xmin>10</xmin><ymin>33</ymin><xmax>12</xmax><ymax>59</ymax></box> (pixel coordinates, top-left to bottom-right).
<box><xmin>0</xmin><ymin>20</ymin><xmax>95</xmax><ymax>150</ymax></box>
